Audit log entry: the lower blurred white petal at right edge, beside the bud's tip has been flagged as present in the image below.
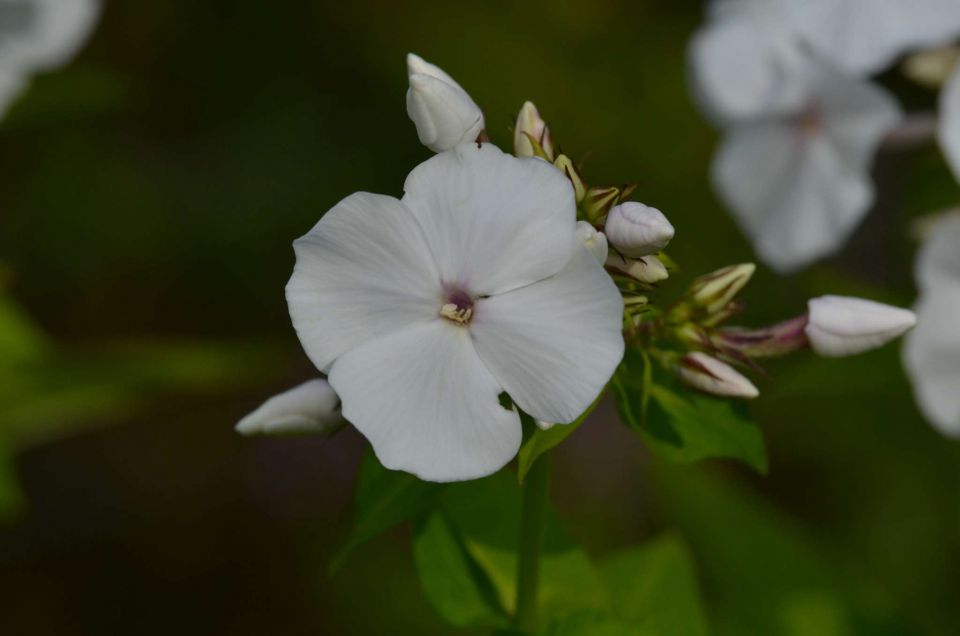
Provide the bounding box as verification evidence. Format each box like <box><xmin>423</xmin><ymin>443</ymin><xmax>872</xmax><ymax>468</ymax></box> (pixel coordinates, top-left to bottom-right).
<box><xmin>903</xmin><ymin>288</ymin><xmax>960</xmax><ymax>437</ymax></box>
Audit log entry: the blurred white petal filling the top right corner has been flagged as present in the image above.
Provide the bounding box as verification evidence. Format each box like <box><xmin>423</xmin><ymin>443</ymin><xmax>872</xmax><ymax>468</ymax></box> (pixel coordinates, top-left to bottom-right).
<box><xmin>777</xmin><ymin>0</ymin><xmax>960</xmax><ymax>75</ymax></box>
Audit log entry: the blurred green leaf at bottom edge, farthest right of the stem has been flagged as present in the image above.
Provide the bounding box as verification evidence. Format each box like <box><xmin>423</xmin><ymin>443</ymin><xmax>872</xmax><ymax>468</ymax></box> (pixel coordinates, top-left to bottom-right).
<box><xmin>599</xmin><ymin>535</ymin><xmax>709</xmax><ymax>636</ymax></box>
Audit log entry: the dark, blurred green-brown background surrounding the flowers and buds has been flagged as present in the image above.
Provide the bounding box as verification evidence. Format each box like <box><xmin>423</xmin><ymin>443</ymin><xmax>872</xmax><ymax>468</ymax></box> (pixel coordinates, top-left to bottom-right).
<box><xmin>0</xmin><ymin>0</ymin><xmax>960</xmax><ymax>636</ymax></box>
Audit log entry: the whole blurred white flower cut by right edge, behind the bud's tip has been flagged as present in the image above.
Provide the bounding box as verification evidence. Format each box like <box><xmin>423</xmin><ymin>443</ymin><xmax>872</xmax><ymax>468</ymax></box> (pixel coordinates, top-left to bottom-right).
<box><xmin>903</xmin><ymin>217</ymin><xmax>960</xmax><ymax>437</ymax></box>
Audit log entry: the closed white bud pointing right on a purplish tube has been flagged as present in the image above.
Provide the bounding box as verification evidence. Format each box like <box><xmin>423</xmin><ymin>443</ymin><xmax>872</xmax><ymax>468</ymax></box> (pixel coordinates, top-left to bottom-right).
<box><xmin>806</xmin><ymin>296</ymin><xmax>917</xmax><ymax>358</ymax></box>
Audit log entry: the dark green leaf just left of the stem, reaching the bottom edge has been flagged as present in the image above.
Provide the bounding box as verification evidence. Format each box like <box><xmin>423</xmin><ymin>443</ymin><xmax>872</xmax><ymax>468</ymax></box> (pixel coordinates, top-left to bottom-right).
<box><xmin>413</xmin><ymin>512</ymin><xmax>509</xmax><ymax>629</ymax></box>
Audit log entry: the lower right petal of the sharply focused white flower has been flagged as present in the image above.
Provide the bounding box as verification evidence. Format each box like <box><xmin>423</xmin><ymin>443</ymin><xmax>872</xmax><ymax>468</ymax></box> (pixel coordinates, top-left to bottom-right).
<box><xmin>470</xmin><ymin>248</ymin><xmax>624</xmax><ymax>424</ymax></box>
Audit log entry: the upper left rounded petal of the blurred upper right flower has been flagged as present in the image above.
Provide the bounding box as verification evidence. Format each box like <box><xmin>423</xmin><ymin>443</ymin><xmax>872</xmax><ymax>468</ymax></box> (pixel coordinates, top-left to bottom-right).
<box><xmin>688</xmin><ymin>0</ymin><xmax>806</xmax><ymax>124</ymax></box>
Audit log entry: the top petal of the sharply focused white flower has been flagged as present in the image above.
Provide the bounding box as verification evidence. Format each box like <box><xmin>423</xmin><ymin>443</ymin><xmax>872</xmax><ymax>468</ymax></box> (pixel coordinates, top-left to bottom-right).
<box><xmin>403</xmin><ymin>144</ymin><xmax>576</xmax><ymax>294</ymax></box>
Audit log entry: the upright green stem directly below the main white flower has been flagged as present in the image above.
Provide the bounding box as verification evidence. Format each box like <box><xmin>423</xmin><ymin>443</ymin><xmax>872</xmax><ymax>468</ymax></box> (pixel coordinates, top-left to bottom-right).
<box><xmin>514</xmin><ymin>453</ymin><xmax>550</xmax><ymax>633</ymax></box>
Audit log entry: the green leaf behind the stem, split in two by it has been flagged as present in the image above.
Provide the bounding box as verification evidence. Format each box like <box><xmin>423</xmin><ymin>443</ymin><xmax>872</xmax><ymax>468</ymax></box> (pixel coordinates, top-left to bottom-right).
<box><xmin>440</xmin><ymin>471</ymin><xmax>609</xmax><ymax>624</ymax></box>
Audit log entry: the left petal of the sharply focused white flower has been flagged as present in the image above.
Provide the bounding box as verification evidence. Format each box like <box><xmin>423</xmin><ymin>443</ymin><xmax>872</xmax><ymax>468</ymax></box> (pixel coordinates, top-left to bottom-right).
<box><xmin>287</xmin><ymin>192</ymin><xmax>440</xmax><ymax>370</ymax></box>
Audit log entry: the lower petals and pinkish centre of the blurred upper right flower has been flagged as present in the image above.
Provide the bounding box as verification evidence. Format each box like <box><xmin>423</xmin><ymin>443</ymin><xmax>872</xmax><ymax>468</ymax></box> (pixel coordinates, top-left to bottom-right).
<box><xmin>711</xmin><ymin>65</ymin><xmax>902</xmax><ymax>272</ymax></box>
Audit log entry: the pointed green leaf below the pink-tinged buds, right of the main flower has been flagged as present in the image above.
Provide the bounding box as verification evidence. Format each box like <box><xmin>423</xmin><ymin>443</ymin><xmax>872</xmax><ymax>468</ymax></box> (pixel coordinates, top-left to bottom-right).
<box><xmin>613</xmin><ymin>351</ymin><xmax>767</xmax><ymax>473</ymax></box>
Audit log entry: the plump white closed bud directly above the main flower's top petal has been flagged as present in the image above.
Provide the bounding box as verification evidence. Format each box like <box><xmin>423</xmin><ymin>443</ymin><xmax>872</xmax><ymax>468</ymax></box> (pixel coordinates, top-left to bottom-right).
<box><xmin>407</xmin><ymin>53</ymin><xmax>484</xmax><ymax>152</ymax></box>
